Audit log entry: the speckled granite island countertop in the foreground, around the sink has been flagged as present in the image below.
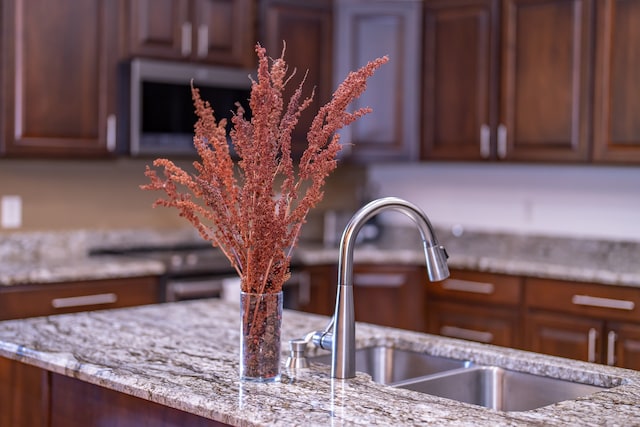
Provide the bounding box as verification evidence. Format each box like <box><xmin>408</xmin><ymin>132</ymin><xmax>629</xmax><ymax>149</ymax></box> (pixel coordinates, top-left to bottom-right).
<box><xmin>0</xmin><ymin>300</ymin><xmax>640</xmax><ymax>426</ymax></box>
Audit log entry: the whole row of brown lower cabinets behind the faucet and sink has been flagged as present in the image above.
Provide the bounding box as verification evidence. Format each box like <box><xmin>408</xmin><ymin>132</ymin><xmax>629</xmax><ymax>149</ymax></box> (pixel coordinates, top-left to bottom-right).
<box><xmin>300</xmin><ymin>264</ymin><xmax>640</xmax><ymax>370</ymax></box>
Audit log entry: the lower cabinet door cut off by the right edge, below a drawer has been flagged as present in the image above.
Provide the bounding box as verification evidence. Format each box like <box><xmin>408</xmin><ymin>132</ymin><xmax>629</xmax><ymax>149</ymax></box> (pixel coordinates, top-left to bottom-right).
<box><xmin>607</xmin><ymin>323</ymin><xmax>640</xmax><ymax>371</ymax></box>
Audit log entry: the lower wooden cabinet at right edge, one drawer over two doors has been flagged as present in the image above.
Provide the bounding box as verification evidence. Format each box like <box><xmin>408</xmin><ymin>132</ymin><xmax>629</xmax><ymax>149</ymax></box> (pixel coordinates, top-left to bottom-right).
<box><xmin>525</xmin><ymin>279</ymin><xmax>640</xmax><ymax>369</ymax></box>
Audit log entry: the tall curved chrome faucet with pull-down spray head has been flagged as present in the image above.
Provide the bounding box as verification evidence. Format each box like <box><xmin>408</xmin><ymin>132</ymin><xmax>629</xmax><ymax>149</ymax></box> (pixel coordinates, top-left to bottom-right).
<box><xmin>309</xmin><ymin>197</ymin><xmax>449</xmax><ymax>378</ymax></box>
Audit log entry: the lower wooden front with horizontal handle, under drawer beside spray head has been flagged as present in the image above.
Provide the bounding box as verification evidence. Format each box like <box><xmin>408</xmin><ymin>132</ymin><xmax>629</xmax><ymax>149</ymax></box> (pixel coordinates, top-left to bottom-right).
<box><xmin>427</xmin><ymin>302</ymin><xmax>521</xmax><ymax>347</ymax></box>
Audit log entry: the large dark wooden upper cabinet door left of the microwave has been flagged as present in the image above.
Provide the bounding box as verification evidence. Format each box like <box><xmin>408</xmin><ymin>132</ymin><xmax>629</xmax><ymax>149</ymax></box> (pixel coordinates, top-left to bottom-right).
<box><xmin>0</xmin><ymin>0</ymin><xmax>118</xmax><ymax>157</ymax></box>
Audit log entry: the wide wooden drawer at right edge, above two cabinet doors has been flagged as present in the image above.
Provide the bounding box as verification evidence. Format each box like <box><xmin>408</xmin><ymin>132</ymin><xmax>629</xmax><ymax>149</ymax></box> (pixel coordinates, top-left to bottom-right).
<box><xmin>525</xmin><ymin>278</ymin><xmax>640</xmax><ymax>322</ymax></box>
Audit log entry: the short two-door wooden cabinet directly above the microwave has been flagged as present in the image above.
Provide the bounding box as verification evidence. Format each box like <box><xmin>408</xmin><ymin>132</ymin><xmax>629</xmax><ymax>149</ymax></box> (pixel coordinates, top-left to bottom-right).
<box><xmin>127</xmin><ymin>0</ymin><xmax>256</xmax><ymax>67</ymax></box>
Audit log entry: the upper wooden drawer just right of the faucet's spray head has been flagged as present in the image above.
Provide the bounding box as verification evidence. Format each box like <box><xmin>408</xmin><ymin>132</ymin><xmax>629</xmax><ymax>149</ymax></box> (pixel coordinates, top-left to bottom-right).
<box><xmin>427</xmin><ymin>270</ymin><xmax>522</xmax><ymax>305</ymax></box>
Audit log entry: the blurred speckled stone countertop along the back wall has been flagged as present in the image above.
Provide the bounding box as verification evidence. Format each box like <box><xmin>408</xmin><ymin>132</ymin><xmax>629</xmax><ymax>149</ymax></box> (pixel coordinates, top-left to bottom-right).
<box><xmin>0</xmin><ymin>227</ymin><xmax>640</xmax><ymax>287</ymax></box>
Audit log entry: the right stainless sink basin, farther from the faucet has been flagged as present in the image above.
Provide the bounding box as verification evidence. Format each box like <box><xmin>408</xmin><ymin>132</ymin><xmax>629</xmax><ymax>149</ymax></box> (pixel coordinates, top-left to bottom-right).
<box><xmin>395</xmin><ymin>366</ymin><xmax>604</xmax><ymax>411</ymax></box>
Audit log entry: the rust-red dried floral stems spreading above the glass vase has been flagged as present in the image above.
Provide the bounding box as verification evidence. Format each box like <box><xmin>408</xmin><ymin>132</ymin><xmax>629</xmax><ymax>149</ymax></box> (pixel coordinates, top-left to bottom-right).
<box><xmin>141</xmin><ymin>44</ymin><xmax>388</xmax><ymax>293</ymax></box>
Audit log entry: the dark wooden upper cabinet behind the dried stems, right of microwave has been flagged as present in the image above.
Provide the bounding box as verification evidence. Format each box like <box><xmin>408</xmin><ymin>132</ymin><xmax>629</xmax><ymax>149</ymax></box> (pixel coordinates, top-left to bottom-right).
<box><xmin>260</xmin><ymin>0</ymin><xmax>333</xmax><ymax>155</ymax></box>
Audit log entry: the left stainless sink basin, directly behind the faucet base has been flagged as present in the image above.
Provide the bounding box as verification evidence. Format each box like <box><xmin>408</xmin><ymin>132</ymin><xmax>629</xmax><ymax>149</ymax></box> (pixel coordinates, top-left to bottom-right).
<box><xmin>309</xmin><ymin>346</ymin><xmax>471</xmax><ymax>385</ymax></box>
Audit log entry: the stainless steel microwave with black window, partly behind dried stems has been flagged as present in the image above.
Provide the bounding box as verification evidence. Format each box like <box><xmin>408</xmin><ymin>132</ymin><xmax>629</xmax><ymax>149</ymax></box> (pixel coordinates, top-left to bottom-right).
<box><xmin>118</xmin><ymin>58</ymin><xmax>254</xmax><ymax>156</ymax></box>
